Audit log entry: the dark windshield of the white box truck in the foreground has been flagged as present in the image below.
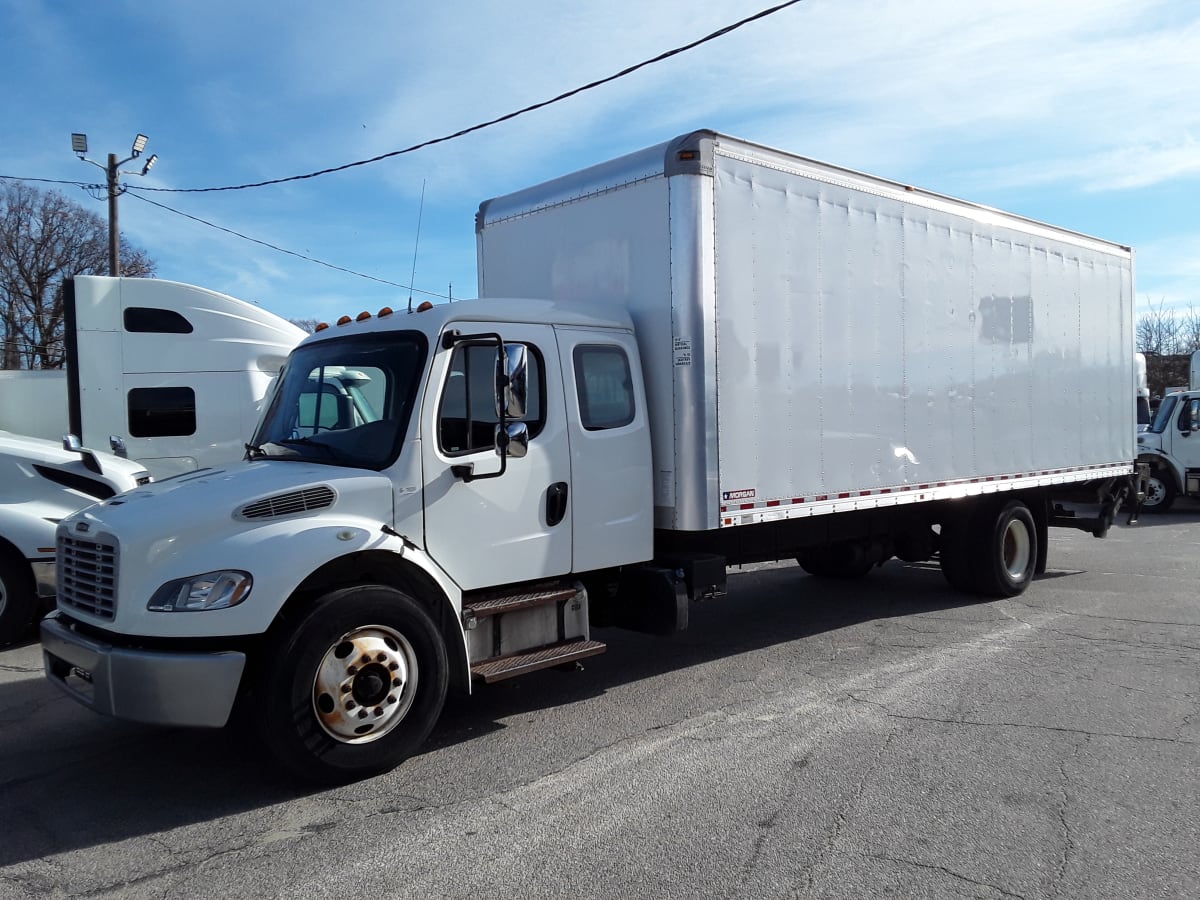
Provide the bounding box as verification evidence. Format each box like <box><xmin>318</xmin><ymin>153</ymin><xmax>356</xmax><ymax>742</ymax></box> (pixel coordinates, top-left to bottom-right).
<box><xmin>246</xmin><ymin>331</ymin><xmax>426</xmax><ymax>469</ymax></box>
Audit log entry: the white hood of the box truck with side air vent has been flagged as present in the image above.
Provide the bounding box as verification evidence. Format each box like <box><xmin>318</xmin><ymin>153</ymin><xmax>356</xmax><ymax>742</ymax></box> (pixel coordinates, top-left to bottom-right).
<box><xmin>58</xmin><ymin>460</ymin><xmax>397</xmax><ymax>637</ymax></box>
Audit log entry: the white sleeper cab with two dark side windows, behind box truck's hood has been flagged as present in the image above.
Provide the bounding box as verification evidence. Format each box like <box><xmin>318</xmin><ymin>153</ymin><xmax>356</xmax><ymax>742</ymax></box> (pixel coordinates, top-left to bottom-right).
<box><xmin>0</xmin><ymin>276</ymin><xmax>305</xmax><ymax>479</ymax></box>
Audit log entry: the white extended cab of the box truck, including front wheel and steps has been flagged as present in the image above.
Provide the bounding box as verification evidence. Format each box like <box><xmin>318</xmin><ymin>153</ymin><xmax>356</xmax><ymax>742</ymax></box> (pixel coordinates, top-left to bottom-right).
<box><xmin>42</xmin><ymin>300</ymin><xmax>653</xmax><ymax>780</ymax></box>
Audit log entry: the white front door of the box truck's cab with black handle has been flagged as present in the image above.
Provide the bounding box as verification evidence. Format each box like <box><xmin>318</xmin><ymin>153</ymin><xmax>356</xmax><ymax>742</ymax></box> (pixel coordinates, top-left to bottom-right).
<box><xmin>421</xmin><ymin>322</ymin><xmax>572</xmax><ymax>590</ymax></box>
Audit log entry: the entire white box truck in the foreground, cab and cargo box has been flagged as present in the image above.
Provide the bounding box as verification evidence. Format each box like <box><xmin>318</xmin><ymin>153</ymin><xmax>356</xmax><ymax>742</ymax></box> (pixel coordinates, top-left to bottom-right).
<box><xmin>42</xmin><ymin>132</ymin><xmax>1134</xmax><ymax>781</ymax></box>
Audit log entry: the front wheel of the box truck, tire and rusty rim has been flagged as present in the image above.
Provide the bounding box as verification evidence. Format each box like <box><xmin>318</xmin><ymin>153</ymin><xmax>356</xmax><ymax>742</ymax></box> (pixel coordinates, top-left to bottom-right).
<box><xmin>258</xmin><ymin>586</ymin><xmax>448</xmax><ymax>784</ymax></box>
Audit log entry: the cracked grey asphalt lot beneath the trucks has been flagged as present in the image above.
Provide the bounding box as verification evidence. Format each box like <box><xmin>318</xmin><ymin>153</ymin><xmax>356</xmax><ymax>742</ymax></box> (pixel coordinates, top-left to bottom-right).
<box><xmin>0</xmin><ymin>503</ymin><xmax>1200</xmax><ymax>898</ymax></box>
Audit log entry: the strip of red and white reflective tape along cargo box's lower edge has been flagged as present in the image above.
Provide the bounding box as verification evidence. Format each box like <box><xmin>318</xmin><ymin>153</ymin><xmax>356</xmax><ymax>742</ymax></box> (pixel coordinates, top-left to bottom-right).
<box><xmin>721</xmin><ymin>463</ymin><xmax>1133</xmax><ymax>526</ymax></box>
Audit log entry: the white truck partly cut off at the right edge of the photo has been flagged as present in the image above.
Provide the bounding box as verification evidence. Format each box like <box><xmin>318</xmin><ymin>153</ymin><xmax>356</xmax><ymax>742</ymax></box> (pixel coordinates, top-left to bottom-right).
<box><xmin>1138</xmin><ymin>350</ymin><xmax>1200</xmax><ymax>512</ymax></box>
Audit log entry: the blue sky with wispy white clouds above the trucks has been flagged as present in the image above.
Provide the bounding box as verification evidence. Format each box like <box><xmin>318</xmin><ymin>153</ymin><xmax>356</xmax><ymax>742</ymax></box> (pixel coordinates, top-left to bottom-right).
<box><xmin>0</xmin><ymin>0</ymin><xmax>1200</xmax><ymax>319</ymax></box>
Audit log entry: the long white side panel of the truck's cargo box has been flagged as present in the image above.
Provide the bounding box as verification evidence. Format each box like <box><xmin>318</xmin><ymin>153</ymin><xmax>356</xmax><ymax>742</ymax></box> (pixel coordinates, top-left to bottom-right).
<box><xmin>713</xmin><ymin>144</ymin><xmax>1133</xmax><ymax>524</ymax></box>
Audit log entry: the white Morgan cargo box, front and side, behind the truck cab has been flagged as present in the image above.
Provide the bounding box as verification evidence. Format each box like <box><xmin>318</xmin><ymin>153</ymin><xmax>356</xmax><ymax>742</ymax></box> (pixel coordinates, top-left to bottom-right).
<box><xmin>476</xmin><ymin>132</ymin><xmax>1135</xmax><ymax>530</ymax></box>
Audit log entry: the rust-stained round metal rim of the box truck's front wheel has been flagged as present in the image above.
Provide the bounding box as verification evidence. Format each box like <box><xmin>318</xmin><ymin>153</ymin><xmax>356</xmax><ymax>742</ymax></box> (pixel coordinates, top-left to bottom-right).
<box><xmin>312</xmin><ymin>625</ymin><xmax>418</xmax><ymax>744</ymax></box>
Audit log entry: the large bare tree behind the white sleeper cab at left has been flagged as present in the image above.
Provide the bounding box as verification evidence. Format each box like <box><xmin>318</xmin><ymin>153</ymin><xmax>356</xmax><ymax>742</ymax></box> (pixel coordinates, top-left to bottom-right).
<box><xmin>0</xmin><ymin>181</ymin><xmax>155</xmax><ymax>368</ymax></box>
